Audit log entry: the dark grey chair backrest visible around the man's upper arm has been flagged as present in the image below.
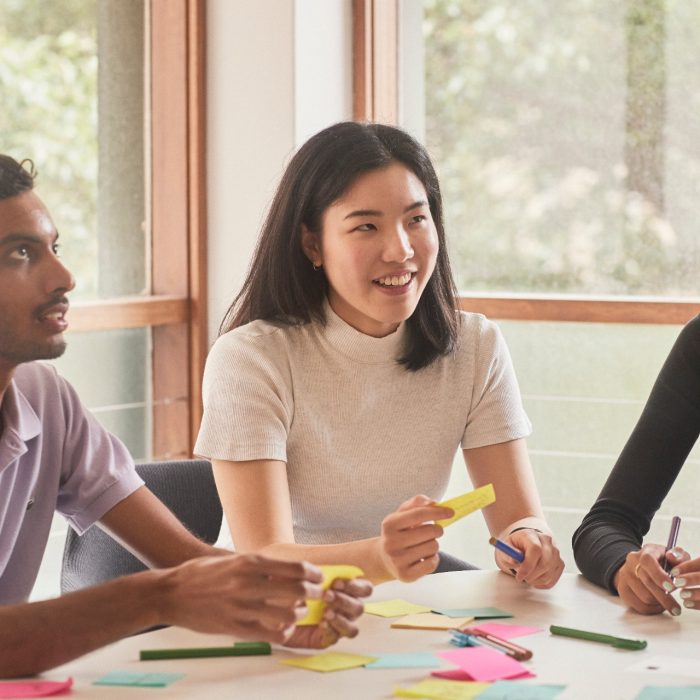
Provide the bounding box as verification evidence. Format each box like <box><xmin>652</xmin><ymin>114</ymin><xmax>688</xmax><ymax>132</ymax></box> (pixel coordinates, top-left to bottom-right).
<box><xmin>61</xmin><ymin>460</ymin><xmax>223</xmax><ymax>593</ymax></box>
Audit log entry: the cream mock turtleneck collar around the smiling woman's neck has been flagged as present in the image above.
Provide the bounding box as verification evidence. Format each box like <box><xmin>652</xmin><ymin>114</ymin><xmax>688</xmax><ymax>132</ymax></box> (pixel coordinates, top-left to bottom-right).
<box><xmin>323</xmin><ymin>300</ymin><xmax>406</xmax><ymax>365</ymax></box>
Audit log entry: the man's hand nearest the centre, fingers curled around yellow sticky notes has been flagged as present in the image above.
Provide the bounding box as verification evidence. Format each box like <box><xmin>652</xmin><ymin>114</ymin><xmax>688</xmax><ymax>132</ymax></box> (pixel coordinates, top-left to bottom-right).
<box><xmin>284</xmin><ymin>578</ymin><xmax>372</xmax><ymax>649</ymax></box>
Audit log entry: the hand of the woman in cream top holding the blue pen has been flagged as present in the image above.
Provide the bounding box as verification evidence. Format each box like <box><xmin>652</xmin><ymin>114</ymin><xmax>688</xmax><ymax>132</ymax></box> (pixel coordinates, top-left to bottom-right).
<box><xmin>496</xmin><ymin>528</ymin><xmax>564</xmax><ymax>588</ymax></box>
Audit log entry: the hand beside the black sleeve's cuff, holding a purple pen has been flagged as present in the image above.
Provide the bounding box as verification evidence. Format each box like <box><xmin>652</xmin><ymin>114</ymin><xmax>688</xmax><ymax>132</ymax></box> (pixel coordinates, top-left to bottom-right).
<box><xmin>613</xmin><ymin>544</ymin><xmax>690</xmax><ymax>615</ymax></box>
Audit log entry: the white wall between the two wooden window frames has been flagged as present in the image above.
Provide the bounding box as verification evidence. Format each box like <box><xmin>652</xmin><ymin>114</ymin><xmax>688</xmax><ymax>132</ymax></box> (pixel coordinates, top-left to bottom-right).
<box><xmin>207</xmin><ymin>0</ymin><xmax>352</xmax><ymax>342</ymax></box>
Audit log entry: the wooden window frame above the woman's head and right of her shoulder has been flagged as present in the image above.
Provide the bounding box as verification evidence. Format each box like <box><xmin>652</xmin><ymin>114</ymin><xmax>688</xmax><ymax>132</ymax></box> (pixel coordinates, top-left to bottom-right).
<box><xmin>352</xmin><ymin>0</ymin><xmax>700</xmax><ymax>324</ymax></box>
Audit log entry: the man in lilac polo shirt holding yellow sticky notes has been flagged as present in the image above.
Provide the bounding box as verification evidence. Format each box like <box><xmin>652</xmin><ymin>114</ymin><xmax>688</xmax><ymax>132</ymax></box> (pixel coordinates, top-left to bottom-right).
<box><xmin>0</xmin><ymin>155</ymin><xmax>371</xmax><ymax>677</ymax></box>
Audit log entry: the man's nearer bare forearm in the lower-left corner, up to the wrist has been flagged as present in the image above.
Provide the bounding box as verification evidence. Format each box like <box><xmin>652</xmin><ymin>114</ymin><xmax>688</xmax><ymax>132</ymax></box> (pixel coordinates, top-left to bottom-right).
<box><xmin>0</xmin><ymin>571</ymin><xmax>163</xmax><ymax>678</ymax></box>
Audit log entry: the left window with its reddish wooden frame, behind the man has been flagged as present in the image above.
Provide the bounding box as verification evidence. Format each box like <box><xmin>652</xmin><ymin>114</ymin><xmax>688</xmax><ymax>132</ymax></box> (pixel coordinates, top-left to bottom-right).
<box><xmin>0</xmin><ymin>0</ymin><xmax>206</xmax><ymax>459</ymax></box>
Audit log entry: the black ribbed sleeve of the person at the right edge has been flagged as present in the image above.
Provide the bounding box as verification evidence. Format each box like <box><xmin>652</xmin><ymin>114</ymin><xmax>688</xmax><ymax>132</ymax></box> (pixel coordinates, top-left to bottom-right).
<box><xmin>573</xmin><ymin>316</ymin><xmax>700</xmax><ymax>593</ymax></box>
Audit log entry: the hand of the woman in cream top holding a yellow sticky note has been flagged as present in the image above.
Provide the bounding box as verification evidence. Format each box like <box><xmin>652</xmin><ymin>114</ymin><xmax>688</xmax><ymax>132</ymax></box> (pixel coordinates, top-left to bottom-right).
<box><xmin>379</xmin><ymin>495</ymin><xmax>454</xmax><ymax>581</ymax></box>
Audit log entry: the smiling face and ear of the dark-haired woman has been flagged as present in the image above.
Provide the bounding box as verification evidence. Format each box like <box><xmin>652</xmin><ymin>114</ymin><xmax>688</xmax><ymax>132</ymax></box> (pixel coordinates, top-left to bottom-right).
<box><xmin>302</xmin><ymin>162</ymin><xmax>438</xmax><ymax>337</ymax></box>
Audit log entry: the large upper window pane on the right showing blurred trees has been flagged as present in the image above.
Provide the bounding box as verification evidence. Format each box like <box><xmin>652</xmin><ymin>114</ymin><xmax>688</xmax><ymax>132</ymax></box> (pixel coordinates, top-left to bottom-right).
<box><xmin>416</xmin><ymin>0</ymin><xmax>700</xmax><ymax>297</ymax></box>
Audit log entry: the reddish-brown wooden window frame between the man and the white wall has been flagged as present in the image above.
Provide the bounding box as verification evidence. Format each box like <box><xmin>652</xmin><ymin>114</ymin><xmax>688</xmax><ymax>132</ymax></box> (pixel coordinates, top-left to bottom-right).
<box><xmin>70</xmin><ymin>0</ymin><xmax>208</xmax><ymax>459</ymax></box>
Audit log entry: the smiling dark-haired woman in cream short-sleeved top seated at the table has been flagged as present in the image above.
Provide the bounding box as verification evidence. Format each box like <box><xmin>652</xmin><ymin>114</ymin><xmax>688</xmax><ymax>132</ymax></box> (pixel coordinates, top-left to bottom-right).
<box><xmin>195</xmin><ymin>122</ymin><xmax>563</xmax><ymax>588</ymax></box>
